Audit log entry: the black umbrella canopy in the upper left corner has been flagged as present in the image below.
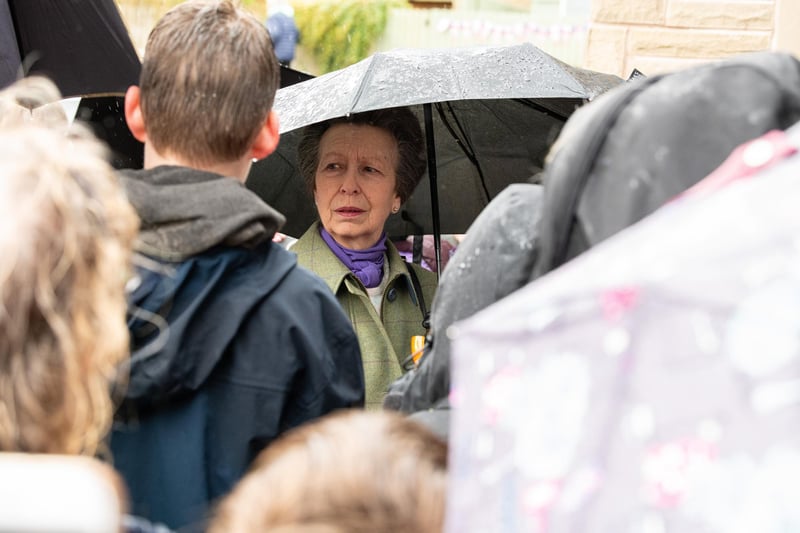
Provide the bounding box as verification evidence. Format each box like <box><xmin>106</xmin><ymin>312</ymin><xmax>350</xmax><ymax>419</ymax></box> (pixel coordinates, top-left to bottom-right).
<box><xmin>0</xmin><ymin>0</ymin><xmax>141</xmax><ymax>96</ymax></box>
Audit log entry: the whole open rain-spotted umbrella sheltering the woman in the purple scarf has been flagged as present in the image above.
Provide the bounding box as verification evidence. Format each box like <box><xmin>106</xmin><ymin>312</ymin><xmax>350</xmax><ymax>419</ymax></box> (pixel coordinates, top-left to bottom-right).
<box><xmin>248</xmin><ymin>44</ymin><xmax>622</xmax><ymax>270</ymax></box>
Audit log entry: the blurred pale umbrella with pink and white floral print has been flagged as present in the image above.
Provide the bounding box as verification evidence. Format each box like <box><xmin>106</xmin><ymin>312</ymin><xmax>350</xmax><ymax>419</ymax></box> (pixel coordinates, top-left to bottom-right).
<box><xmin>446</xmin><ymin>128</ymin><xmax>800</xmax><ymax>533</ymax></box>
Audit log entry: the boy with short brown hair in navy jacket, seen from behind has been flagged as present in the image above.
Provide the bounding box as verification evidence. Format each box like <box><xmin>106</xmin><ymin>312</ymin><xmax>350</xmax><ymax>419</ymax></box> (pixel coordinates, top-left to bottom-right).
<box><xmin>111</xmin><ymin>1</ymin><xmax>364</xmax><ymax>528</ymax></box>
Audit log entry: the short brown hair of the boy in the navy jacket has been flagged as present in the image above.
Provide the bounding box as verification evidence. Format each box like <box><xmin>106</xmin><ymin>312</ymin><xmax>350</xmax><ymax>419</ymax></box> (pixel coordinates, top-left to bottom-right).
<box><xmin>139</xmin><ymin>0</ymin><xmax>280</xmax><ymax>164</ymax></box>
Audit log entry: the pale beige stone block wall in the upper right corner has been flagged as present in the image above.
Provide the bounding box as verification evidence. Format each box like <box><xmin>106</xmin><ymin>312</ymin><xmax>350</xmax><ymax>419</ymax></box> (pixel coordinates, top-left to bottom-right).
<box><xmin>584</xmin><ymin>0</ymin><xmax>800</xmax><ymax>77</ymax></box>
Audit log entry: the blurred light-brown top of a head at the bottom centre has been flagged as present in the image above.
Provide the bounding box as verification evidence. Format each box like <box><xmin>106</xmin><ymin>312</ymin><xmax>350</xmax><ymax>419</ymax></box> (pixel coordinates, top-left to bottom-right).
<box><xmin>209</xmin><ymin>411</ymin><xmax>447</xmax><ymax>533</ymax></box>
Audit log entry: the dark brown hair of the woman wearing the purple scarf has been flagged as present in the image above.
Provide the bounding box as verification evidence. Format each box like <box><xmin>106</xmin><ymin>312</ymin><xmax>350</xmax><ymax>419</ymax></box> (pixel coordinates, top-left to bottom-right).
<box><xmin>297</xmin><ymin>107</ymin><xmax>425</xmax><ymax>203</ymax></box>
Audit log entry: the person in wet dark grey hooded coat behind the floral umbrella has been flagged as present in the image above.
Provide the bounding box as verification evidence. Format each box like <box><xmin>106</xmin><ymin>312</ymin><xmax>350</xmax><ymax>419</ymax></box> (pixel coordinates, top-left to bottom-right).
<box><xmin>385</xmin><ymin>52</ymin><xmax>800</xmax><ymax>440</ymax></box>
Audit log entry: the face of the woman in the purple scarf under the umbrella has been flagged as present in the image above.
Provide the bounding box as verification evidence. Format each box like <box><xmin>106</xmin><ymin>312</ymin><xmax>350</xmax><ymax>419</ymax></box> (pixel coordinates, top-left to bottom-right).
<box><xmin>314</xmin><ymin>124</ymin><xmax>400</xmax><ymax>250</ymax></box>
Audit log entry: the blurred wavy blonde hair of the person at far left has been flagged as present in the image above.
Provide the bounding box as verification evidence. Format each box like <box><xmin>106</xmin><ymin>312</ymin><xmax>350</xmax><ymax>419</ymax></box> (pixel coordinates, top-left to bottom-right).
<box><xmin>0</xmin><ymin>119</ymin><xmax>138</xmax><ymax>454</ymax></box>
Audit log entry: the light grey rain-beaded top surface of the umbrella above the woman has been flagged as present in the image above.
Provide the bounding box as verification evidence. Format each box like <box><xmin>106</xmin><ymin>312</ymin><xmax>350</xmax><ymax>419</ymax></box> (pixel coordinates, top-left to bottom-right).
<box><xmin>268</xmin><ymin>43</ymin><xmax>621</xmax><ymax>128</ymax></box>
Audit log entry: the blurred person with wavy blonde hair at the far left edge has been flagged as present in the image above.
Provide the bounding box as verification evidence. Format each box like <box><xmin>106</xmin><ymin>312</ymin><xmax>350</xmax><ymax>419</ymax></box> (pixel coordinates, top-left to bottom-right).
<box><xmin>0</xmin><ymin>77</ymin><xmax>148</xmax><ymax>533</ymax></box>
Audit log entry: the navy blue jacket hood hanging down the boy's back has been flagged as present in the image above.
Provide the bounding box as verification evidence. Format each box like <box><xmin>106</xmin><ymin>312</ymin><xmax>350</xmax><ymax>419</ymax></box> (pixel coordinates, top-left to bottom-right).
<box><xmin>121</xmin><ymin>241</ymin><xmax>296</xmax><ymax>416</ymax></box>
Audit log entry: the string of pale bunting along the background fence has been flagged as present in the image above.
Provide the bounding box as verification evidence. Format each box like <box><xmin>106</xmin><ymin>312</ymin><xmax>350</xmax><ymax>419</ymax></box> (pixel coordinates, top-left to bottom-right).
<box><xmin>436</xmin><ymin>19</ymin><xmax>587</xmax><ymax>41</ymax></box>
